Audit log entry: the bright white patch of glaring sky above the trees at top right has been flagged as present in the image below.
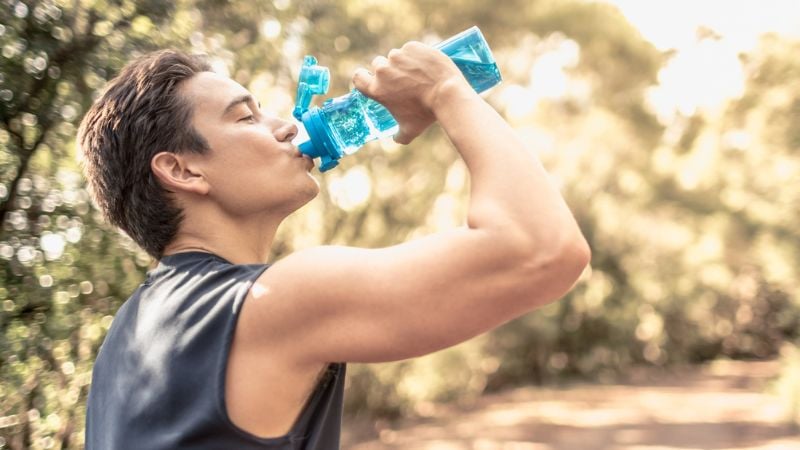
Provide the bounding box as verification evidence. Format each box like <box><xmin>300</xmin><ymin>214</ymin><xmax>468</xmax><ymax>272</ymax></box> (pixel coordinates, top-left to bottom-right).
<box><xmin>598</xmin><ymin>0</ymin><xmax>800</xmax><ymax>123</ymax></box>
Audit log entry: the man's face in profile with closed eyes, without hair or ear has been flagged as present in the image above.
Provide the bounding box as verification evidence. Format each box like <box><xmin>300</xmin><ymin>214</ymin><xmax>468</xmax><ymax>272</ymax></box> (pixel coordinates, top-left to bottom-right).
<box><xmin>181</xmin><ymin>72</ymin><xmax>319</xmax><ymax>216</ymax></box>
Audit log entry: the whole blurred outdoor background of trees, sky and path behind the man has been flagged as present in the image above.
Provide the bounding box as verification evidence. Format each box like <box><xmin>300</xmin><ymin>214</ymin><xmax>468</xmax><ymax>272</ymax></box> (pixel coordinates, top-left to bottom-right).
<box><xmin>0</xmin><ymin>0</ymin><xmax>800</xmax><ymax>450</ymax></box>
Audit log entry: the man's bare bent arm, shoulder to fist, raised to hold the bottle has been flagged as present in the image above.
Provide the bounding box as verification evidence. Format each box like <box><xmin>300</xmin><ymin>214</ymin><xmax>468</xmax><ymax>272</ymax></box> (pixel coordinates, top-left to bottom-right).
<box><xmin>245</xmin><ymin>43</ymin><xmax>590</xmax><ymax>363</ymax></box>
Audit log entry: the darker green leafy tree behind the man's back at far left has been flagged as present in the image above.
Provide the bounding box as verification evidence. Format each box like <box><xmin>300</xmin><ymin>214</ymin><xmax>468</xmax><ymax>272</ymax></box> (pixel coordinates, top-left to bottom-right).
<box><xmin>0</xmin><ymin>0</ymin><xmax>195</xmax><ymax>448</ymax></box>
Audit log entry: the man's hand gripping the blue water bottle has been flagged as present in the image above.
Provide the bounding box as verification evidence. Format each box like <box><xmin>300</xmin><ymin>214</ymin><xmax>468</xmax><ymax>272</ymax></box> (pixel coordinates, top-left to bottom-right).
<box><xmin>353</xmin><ymin>42</ymin><xmax>477</xmax><ymax>144</ymax></box>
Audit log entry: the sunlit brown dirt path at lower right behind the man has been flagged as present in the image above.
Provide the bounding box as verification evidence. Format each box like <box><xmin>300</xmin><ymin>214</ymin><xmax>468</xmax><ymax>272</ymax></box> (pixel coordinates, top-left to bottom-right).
<box><xmin>342</xmin><ymin>362</ymin><xmax>800</xmax><ymax>450</ymax></box>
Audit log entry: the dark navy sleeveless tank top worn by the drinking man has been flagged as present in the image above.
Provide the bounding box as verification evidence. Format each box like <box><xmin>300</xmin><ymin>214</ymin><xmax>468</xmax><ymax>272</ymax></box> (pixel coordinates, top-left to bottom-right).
<box><xmin>86</xmin><ymin>252</ymin><xmax>345</xmax><ymax>450</ymax></box>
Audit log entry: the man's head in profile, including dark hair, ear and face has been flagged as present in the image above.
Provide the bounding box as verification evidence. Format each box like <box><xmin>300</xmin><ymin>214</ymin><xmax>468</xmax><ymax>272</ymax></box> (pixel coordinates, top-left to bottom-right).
<box><xmin>78</xmin><ymin>50</ymin><xmax>318</xmax><ymax>258</ymax></box>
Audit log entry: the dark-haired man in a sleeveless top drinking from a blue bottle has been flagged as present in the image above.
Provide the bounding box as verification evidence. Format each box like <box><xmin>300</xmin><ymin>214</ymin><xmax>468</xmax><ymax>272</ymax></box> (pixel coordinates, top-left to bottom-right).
<box><xmin>79</xmin><ymin>42</ymin><xmax>589</xmax><ymax>450</ymax></box>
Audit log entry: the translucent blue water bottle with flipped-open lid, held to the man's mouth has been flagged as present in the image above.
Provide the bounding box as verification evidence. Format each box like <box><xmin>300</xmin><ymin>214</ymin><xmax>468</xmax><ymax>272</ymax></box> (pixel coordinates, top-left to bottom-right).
<box><xmin>293</xmin><ymin>27</ymin><xmax>501</xmax><ymax>172</ymax></box>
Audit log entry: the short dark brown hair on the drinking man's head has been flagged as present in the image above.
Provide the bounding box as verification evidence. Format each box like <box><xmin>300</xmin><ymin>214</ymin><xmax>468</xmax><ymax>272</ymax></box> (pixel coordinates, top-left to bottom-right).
<box><xmin>78</xmin><ymin>50</ymin><xmax>210</xmax><ymax>259</ymax></box>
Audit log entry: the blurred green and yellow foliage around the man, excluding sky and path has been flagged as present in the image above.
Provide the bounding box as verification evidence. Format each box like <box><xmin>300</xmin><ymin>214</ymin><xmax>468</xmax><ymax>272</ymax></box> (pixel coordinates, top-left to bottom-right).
<box><xmin>0</xmin><ymin>0</ymin><xmax>800</xmax><ymax>449</ymax></box>
